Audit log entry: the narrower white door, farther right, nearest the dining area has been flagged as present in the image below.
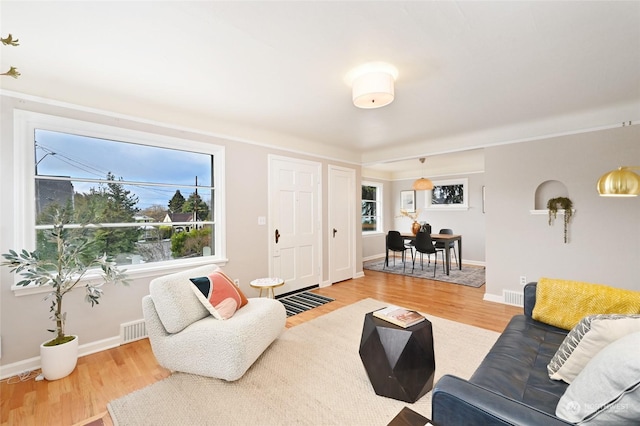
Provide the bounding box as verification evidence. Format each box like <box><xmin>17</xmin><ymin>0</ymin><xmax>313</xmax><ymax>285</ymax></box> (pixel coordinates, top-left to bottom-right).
<box><xmin>329</xmin><ymin>166</ymin><xmax>356</xmax><ymax>284</ymax></box>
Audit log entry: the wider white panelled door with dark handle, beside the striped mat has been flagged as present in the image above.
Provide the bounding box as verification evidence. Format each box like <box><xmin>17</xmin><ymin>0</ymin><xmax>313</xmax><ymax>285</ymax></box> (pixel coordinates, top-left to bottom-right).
<box><xmin>269</xmin><ymin>156</ymin><xmax>322</xmax><ymax>294</ymax></box>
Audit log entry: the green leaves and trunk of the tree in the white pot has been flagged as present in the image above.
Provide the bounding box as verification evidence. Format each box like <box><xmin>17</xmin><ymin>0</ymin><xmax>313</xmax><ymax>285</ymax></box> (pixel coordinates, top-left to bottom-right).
<box><xmin>1</xmin><ymin>210</ymin><xmax>128</xmax><ymax>346</ymax></box>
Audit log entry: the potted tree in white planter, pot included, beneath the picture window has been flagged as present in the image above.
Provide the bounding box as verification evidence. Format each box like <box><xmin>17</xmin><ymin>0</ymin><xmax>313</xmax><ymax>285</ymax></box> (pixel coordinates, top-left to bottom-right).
<box><xmin>1</xmin><ymin>210</ymin><xmax>128</xmax><ymax>380</ymax></box>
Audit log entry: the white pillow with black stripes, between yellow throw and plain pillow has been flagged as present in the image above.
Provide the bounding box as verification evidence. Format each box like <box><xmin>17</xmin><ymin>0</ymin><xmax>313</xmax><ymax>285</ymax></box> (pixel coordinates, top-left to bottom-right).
<box><xmin>547</xmin><ymin>314</ymin><xmax>640</xmax><ymax>383</ymax></box>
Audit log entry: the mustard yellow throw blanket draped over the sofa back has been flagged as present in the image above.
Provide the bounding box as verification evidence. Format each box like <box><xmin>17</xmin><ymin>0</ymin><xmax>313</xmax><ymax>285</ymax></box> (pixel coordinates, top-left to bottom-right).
<box><xmin>533</xmin><ymin>278</ymin><xmax>640</xmax><ymax>330</ymax></box>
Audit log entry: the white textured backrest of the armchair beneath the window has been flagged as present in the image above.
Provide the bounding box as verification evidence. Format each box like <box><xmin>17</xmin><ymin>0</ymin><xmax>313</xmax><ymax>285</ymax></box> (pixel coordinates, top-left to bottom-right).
<box><xmin>149</xmin><ymin>264</ymin><xmax>220</xmax><ymax>333</ymax></box>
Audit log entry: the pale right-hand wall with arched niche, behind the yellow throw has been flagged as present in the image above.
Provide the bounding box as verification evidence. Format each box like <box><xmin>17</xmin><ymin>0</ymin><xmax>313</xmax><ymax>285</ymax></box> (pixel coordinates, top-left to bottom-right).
<box><xmin>485</xmin><ymin>126</ymin><xmax>640</xmax><ymax>299</ymax></box>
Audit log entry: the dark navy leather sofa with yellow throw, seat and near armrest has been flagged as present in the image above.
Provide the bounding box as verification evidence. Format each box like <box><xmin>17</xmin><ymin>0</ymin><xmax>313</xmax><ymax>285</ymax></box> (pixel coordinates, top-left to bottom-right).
<box><xmin>432</xmin><ymin>283</ymin><xmax>571</xmax><ymax>426</ymax></box>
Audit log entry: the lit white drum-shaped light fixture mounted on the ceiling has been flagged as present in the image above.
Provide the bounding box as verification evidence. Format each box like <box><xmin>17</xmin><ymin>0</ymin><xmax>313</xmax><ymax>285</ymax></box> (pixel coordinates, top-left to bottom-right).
<box><xmin>346</xmin><ymin>62</ymin><xmax>398</xmax><ymax>109</ymax></box>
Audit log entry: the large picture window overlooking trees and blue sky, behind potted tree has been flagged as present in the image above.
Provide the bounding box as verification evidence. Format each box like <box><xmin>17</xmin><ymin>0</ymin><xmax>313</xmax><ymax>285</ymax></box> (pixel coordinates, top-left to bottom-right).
<box><xmin>17</xmin><ymin>112</ymin><xmax>224</xmax><ymax>284</ymax></box>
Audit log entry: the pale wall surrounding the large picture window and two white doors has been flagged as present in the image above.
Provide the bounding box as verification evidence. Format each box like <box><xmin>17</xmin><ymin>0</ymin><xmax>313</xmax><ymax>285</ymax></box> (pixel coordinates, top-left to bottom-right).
<box><xmin>0</xmin><ymin>95</ymin><xmax>362</xmax><ymax>373</ymax></box>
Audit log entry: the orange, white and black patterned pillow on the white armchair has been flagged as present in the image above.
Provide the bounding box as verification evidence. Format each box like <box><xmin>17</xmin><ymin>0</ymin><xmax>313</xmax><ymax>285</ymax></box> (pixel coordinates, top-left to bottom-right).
<box><xmin>190</xmin><ymin>271</ymin><xmax>247</xmax><ymax>320</ymax></box>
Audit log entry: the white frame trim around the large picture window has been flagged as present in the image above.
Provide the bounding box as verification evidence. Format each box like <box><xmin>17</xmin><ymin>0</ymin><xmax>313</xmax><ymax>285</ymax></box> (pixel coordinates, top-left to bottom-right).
<box><xmin>11</xmin><ymin>109</ymin><xmax>227</xmax><ymax>296</ymax></box>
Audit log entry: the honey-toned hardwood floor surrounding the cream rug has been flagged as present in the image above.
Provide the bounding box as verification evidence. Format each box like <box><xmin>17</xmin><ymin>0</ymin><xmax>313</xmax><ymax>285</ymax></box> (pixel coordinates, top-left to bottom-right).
<box><xmin>0</xmin><ymin>270</ymin><xmax>522</xmax><ymax>426</ymax></box>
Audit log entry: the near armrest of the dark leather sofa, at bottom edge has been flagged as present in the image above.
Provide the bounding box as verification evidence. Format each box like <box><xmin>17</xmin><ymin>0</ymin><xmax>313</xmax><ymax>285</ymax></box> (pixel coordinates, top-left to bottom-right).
<box><xmin>431</xmin><ymin>375</ymin><xmax>571</xmax><ymax>426</ymax></box>
